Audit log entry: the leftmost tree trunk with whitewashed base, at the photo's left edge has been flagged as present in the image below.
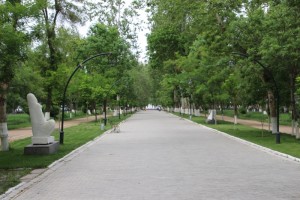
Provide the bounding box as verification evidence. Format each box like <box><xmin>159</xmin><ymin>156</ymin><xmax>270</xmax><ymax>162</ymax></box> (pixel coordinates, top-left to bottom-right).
<box><xmin>0</xmin><ymin>83</ymin><xmax>9</xmax><ymax>151</ymax></box>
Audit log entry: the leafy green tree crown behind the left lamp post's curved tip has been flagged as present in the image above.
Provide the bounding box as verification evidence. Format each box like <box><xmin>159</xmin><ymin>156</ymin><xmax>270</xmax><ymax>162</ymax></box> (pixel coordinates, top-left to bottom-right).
<box><xmin>74</xmin><ymin>24</ymin><xmax>136</xmax><ymax>118</ymax></box>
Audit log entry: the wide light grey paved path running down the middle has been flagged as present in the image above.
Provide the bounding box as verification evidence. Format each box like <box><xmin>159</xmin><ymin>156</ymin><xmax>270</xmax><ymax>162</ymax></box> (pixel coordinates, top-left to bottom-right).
<box><xmin>5</xmin><ymin>111</ymin><xmax>300</xmax><ymax>200</ymax></box>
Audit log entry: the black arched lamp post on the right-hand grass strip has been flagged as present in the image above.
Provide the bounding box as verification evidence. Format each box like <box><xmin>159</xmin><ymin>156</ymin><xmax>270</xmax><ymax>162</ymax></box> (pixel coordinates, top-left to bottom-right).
<box><xmin>232</xmin><ymin>52</ymin><xmax>280</xmax><ymax>144</ymax></box>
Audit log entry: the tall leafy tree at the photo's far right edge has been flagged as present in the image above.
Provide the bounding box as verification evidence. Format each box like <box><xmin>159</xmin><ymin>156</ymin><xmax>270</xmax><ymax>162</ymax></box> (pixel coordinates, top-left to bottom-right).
<box><xmin>259</xmin><ymin>1</ymin><xmax>300</xmax><ymax>138</ymax></box>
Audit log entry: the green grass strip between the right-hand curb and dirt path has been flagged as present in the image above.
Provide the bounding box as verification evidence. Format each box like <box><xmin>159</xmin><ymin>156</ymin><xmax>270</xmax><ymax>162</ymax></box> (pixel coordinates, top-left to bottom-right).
<box><xmin>176</xmin><ymin>115</ymin><xmax>300</xmax><ymax>158</ymax></box>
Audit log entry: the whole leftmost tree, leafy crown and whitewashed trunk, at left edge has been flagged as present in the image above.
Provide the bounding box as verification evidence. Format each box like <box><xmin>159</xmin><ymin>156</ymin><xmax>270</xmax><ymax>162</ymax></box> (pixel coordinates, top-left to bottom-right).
<box><xmin>0</xmin><ymin>0</ymin><xmax>27</xmax><ymax>151</ymax></box>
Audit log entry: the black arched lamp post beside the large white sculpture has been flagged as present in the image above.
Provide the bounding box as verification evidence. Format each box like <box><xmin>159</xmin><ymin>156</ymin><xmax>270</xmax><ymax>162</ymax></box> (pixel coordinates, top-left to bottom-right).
<box><xmin>59</xmin><ymin>52</ymin><xmax>112</xmax><ymax>144</ymax></box>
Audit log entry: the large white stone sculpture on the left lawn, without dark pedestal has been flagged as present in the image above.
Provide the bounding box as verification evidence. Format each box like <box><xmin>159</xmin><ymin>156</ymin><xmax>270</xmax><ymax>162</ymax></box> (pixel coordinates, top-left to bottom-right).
<box><xmin>27</xmin><ymin>93</ymin><xmax>55</xmax><ymax>144</ymax></box>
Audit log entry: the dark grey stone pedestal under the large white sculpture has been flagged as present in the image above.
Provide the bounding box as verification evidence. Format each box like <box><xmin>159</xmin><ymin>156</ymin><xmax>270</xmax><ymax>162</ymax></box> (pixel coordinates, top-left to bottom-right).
<box><xmin>24</xmin><ymin>141</ymin><xmax>59</xmax><ymax>155</ymax></box>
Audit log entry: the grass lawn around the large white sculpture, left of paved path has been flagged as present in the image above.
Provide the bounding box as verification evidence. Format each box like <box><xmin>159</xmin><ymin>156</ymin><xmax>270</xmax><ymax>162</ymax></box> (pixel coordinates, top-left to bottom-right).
<box><xmin>0</xmin><ymin>115</ymin><xmax>130</xmax><ymax>194</ymax></box>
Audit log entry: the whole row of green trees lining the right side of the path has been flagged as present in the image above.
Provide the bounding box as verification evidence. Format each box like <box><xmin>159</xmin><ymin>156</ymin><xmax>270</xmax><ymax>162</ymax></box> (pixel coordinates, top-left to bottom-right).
<box><xmin>146</xmin><ymin>0</ymin><xmax>300</xmax><ymax>136</ymax></box>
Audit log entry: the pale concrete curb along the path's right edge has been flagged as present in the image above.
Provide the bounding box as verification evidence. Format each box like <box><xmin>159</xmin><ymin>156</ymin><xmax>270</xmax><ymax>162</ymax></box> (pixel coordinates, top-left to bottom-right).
<box><xmin>170</xmin><ymin>113</ymin><xmax>300</xmax><ymax>164</ymax></box>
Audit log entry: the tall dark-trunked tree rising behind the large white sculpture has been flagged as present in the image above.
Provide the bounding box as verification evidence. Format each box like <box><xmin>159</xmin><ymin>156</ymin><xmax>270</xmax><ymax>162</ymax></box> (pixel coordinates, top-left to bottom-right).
<box><xmin>34</xmin><ymin>0</ymin><xmax>87</xmax><ymax>115</ymax></box>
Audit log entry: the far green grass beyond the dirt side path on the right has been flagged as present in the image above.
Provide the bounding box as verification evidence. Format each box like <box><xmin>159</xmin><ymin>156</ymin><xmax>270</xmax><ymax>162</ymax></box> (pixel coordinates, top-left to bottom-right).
<box><xmin>218</xmin><ymin>110</ymin><xmax>292</xmax><ymax>126</ymax></box>
